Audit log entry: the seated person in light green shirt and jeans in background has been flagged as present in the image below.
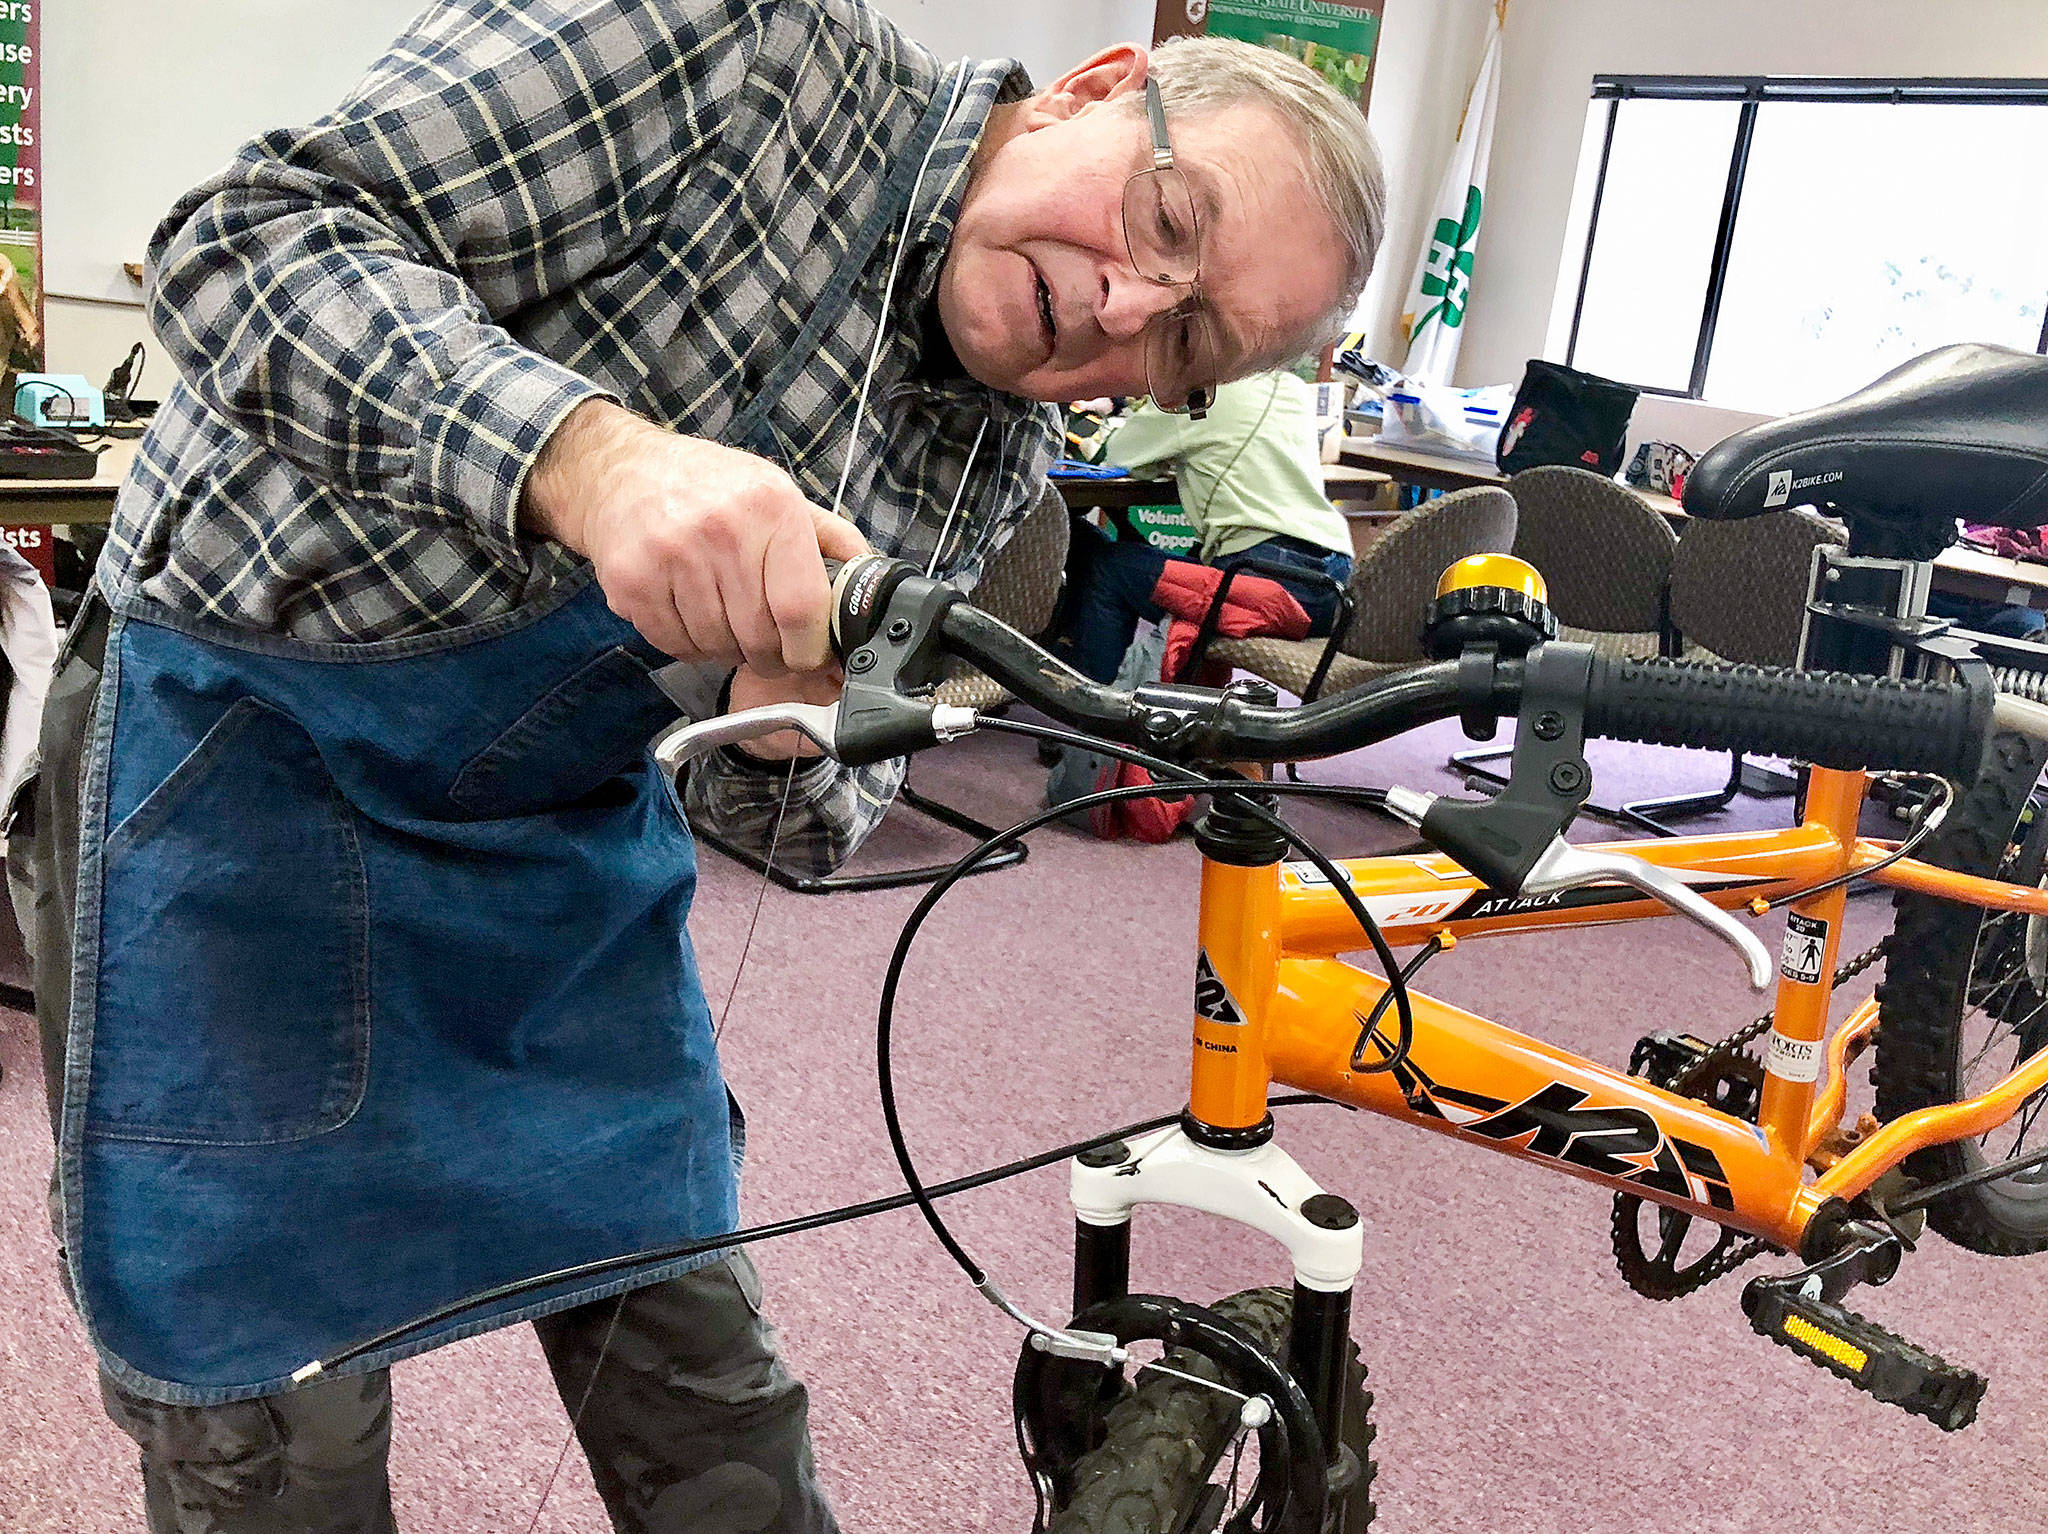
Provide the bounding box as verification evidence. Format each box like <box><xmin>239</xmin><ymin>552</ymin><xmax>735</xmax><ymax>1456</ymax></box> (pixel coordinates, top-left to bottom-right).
<box><xmin>1065</xmin><ymin>371</ymin><xmax>1352</xmax><ymax>682</ymax></box>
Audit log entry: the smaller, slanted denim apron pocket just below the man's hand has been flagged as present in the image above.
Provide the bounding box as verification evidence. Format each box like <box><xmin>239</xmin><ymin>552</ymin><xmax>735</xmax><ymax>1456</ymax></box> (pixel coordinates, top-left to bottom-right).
<box><xmin>449</xmin><ymin>645</ymin><xmax>676</xmax><ymax>817</ymax></box>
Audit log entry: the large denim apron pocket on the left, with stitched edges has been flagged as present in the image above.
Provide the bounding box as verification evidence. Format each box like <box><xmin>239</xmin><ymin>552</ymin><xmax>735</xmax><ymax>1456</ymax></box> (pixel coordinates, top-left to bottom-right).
<box><xmin>86</xmin><ymin>698</ymin><xmax>369</xmax><ymax>1145</ymax></box>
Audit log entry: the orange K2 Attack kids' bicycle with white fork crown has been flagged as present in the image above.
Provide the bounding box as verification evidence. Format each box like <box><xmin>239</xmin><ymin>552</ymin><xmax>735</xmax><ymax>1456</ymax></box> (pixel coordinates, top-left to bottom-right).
<box><xmin>657</xmin><ymin>348</ymin><xmax>2048</xmax><ymax>1534</ymax></box>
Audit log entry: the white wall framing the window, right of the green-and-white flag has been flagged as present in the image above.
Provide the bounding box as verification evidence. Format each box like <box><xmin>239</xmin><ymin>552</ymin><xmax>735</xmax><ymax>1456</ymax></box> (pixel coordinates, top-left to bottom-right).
<box><xmin>1466</xmin><ymin>0</ymin><xmax>2048</xmax><ymax>395</ymax></box>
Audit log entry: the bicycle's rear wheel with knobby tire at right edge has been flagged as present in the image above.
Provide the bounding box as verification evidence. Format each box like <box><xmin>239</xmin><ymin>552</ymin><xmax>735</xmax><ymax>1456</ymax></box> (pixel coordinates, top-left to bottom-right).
<box><xmin>1870</xmin><ymin>733</ymin><xmax>2048</xmax><ymax>1255</ymax></box>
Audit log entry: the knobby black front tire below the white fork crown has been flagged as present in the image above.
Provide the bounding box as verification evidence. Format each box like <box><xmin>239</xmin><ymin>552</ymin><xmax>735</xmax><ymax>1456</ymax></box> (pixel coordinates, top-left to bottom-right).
<box><xmin>1044</xmin><ymin>1288</ymin><xmax>1376</xmax><ymax>1534</ymax></box>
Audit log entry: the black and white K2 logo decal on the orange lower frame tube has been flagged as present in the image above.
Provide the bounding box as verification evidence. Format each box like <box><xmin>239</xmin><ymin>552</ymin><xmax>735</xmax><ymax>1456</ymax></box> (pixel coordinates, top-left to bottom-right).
<box><xmin>1360</xmin><ymin>1018</ymin><xmax>1735</xmax><ymax>1208</ymax></box>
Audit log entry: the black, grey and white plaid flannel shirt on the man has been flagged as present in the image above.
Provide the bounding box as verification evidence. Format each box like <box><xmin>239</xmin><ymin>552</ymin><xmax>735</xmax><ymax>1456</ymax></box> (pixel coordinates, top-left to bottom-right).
<box><xmin>114</xmin><ymin>0</ymin><xmax>1059</xmax><ymax>872</ymax></box>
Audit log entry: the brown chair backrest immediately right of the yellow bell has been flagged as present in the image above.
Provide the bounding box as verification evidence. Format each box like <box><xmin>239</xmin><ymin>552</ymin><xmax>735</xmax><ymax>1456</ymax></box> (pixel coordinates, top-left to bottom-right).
<box><xmin>1507</xmin><ymin>465</ymin><xmax>1677</xmax><ymax>633</ymax></box>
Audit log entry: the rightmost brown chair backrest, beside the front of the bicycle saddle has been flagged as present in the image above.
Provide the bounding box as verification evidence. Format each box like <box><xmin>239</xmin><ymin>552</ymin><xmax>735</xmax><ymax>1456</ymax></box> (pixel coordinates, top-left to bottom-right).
<box><xmin>1671</xmin><ymin>508</ymin><xmax>1849</xmax><ymax>666</ymax></box>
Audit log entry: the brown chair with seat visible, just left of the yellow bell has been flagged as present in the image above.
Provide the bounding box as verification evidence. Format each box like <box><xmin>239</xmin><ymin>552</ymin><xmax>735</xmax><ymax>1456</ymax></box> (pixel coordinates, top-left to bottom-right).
<box><xmin>1190</xmin><ymin>485</ymin><xmax>1516</xmax><ymax>702</ymax></box>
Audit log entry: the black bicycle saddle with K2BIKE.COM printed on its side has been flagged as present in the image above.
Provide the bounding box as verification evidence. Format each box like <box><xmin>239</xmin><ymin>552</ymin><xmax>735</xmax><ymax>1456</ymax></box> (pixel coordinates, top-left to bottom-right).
<box><xmin>1686</xmin><ymin>342</ymin><xmax>2048</xmax><ymax>559</ymax></box>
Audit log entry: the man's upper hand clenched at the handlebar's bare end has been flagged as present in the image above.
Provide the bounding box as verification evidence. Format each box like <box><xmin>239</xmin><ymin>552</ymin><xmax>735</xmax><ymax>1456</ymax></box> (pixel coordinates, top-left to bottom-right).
<box><xmin>520</xmin><ymin>399</ymin><xmax>866</xmax><ymax>671</ymax></box>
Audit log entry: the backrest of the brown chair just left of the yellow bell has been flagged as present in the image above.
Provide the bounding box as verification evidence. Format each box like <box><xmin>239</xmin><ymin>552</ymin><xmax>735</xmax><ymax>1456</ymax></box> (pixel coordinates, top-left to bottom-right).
<box><xmin>1343</xmin><ymin>485</ymin><xmax>1516</xmax><ymax>664</ymax></box>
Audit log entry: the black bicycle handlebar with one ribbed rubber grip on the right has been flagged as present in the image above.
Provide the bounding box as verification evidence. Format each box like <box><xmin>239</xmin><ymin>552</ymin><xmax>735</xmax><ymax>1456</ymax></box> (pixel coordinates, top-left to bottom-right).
<box><xmin>834</xmin><ymin>557</ymin><xmax>1993</xmax><ymax>782</ymax></box>
